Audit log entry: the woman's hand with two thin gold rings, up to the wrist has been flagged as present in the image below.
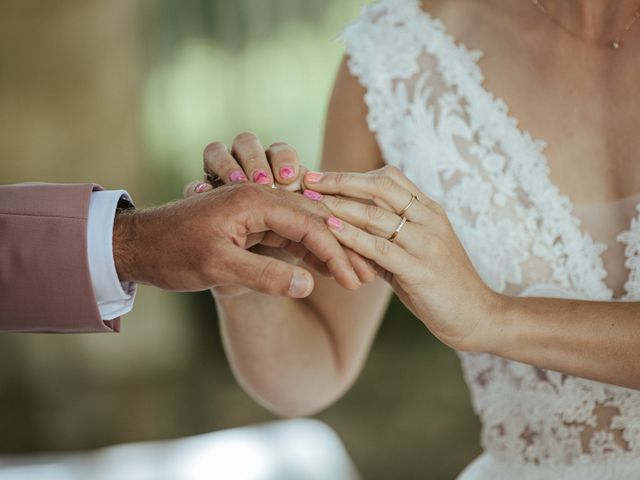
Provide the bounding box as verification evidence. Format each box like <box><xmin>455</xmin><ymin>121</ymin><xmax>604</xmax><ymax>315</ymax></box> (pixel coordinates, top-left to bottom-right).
<box><xmin>304</xmin><ymin>166</ymin><xmax>505</xmax><ymax>351</ymax></box>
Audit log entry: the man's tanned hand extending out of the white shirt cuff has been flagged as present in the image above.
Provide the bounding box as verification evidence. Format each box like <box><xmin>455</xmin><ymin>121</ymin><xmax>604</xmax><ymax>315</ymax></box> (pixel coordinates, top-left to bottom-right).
<box><xmin>113</xmin><ymin>183</ymin><xmax>360</xmax><ymax>298</ymax></box>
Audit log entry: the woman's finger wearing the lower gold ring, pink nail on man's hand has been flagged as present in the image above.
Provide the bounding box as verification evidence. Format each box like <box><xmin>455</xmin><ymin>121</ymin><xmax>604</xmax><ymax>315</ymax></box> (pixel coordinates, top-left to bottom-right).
<box><xmin>322</xmin><ymin>195</ymin><xmax>423</xmax><ymax>255</ymax></box>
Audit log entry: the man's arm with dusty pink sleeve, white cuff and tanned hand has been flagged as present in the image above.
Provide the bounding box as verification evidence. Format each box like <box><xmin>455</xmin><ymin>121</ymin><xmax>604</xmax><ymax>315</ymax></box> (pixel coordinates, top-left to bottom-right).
<box><xmin>0</xmin><ymin>184</ymin><xmax>359</xmax><ymax>332</ymax></box>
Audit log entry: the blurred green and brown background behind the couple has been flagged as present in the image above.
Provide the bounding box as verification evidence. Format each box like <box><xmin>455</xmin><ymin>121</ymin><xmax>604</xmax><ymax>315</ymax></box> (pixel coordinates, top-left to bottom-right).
<box><xmin>0</xmin><ymin>0</ymin><xmax>480</xmax><ymax>479</ymax></box>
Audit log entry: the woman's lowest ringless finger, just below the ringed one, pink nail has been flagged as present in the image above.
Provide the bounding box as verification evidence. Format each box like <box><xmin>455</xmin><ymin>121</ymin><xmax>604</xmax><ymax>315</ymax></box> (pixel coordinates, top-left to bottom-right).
<box><xmin>326</xmin><ymin>217</ymin><xmax>415</xmax><ymax>275</ymax></box>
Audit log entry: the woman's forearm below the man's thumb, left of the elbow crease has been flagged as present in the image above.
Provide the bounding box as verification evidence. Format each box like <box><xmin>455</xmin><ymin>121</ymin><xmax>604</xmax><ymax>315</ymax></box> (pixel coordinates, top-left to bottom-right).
<box><xmin>217</xmin><ymin>293</ymin><xmax>344</xmax><ymax>416</ymax></box>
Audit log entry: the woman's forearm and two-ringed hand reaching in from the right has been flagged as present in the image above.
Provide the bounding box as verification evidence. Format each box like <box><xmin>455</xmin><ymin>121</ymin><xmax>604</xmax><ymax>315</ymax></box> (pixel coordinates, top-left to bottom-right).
<box><xmin>305</xmin><ymin>159</ymin><xmax>640</xmax><ymax>389</ymax></box>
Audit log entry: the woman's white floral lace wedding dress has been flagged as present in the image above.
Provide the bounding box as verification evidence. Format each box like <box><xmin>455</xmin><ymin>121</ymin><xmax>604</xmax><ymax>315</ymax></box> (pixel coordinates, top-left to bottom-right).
<box><xmin>343</xmin><ymin>0</ymin><xmax>640</xmax><ymax>480</ymax></box>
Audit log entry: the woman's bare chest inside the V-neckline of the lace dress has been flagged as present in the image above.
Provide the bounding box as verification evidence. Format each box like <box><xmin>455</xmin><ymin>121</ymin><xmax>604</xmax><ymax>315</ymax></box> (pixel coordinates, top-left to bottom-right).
<box><xmin>470</xmin><ymin>36</ymin><xmax>640</xmax><ymax>203</ymax></box>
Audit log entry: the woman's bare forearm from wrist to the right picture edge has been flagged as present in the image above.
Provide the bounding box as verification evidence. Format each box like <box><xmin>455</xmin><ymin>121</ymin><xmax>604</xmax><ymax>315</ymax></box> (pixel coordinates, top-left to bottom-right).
<box><xmin>487</xmin><ymin>297</ymin><xmax>640</xmax><ymax>389</ymax></box>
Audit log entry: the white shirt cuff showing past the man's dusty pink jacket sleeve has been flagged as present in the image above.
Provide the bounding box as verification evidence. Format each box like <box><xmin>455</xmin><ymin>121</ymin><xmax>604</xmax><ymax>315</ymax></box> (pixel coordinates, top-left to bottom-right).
<box><xmin>87</xmin><ymin>190</ymin><xmax>136</xmax><ymax>321</ymax></box>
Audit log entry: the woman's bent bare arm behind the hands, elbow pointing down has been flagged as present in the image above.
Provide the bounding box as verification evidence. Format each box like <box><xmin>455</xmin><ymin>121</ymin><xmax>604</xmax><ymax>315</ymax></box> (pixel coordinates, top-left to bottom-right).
<box><xmin>217</xmin><ymin>57</ymin><xmax>390</xmax><ymax>416</ymax></box>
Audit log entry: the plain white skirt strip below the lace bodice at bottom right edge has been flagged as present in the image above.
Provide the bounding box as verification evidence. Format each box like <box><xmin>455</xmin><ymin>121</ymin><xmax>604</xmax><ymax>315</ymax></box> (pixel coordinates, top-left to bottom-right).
<box><xmin>457</xmin><ymin>453</ymin><xmax>640</xmax><ymax>480</ymax></box>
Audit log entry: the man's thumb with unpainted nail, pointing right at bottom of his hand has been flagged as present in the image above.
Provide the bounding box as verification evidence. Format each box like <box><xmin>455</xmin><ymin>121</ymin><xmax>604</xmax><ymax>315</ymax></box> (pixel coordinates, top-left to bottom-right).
<box><xmin>229</xmin><ymin>249</ymin><xmax>314</xmax><ymax>298</ymax></box>
